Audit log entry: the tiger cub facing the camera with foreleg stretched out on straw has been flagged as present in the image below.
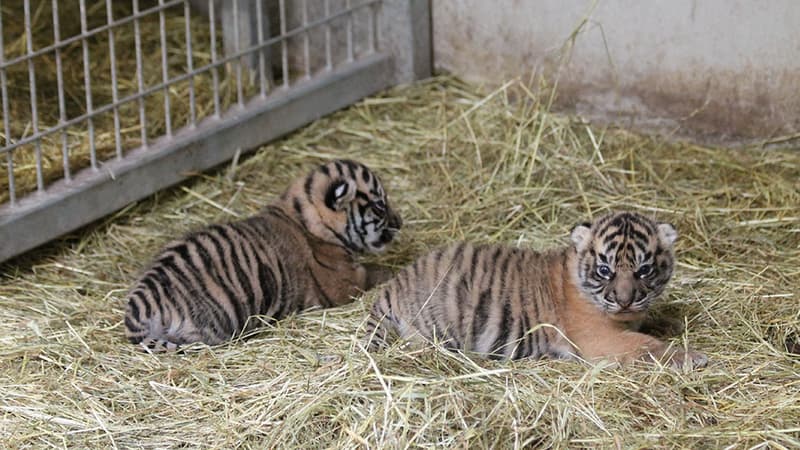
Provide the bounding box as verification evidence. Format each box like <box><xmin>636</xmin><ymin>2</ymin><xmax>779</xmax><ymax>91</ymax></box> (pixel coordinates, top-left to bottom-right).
<box><xmin>366</xmin><ymin>212</ymin><xmax>707</xmax><ymax>367</ymax></box>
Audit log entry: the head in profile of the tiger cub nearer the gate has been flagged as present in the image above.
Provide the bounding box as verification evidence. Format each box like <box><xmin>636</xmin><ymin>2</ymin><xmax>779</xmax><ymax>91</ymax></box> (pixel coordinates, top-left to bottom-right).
<box><xmin>281</xmin><ymin>160</ymin><xmax>403</xmax><ymax>253</ymax></box>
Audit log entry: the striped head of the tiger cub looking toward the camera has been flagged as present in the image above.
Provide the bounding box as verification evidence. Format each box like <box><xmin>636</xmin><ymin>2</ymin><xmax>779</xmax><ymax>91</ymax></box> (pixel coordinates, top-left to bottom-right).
<box><xmin>572</xmin><ymin>212</ymin><xmax>678</xmax><ymax>321</ymax></box>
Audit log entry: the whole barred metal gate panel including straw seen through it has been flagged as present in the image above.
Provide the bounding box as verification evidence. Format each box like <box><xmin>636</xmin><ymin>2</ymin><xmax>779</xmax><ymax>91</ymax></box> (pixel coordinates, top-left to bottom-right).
<box><xmin>0</xmin><ymin>0</ymin><xmax>430</xmax><ymax>261</ymax></box>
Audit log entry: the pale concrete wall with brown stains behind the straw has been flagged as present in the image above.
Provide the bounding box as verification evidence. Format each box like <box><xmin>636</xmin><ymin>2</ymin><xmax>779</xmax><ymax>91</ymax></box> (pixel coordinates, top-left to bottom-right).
<box><xmin>433</xmin><ymin>0</ymin><xmax>800</xmax><ymax>142</ymax></box>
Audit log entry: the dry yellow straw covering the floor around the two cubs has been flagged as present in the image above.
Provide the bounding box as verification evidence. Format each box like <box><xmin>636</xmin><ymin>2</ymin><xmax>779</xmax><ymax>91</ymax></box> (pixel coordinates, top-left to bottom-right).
<box><xmin>0</xmin><ymin>3</ymin><xmax>800</xmax><ymax>449</ymax></box>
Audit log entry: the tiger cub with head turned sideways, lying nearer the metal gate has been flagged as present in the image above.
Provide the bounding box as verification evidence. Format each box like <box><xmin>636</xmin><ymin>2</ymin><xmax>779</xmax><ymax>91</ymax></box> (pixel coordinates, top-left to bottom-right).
<box><xmin>125</xmin><ymin>160</ymin><xmax>402</xmax><ymax>351</ymax></box>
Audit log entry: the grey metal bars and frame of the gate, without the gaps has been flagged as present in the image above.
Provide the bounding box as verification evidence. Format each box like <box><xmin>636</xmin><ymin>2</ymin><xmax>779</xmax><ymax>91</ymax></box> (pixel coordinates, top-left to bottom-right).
<box><xmin>0</xmin><ymin>0</ymin><xmax>431</xmax><ymax>261</ymax></box>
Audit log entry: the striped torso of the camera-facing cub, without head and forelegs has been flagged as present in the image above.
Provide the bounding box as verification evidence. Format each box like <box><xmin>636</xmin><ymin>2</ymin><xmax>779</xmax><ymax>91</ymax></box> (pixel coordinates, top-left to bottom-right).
<box><xmin>368</xmin><ymin>243</ymin><xmax>569</xmax><ymax>358</ymax></box>
